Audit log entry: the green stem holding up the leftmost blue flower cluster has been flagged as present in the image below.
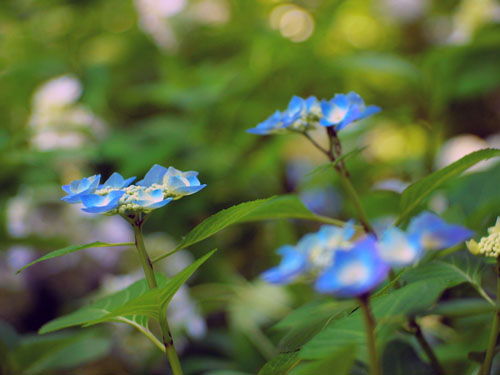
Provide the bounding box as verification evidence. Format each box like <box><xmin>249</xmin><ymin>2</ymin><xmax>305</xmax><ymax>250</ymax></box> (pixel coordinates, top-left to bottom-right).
<box><xmin>132</xmin><ymin>220</ymin><xmax>183</xmax><ymax>375</ymax></box>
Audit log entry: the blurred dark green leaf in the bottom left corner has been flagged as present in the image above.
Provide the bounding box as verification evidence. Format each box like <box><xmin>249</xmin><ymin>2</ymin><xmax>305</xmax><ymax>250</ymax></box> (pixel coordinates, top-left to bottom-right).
<box><xmin>13</xmin><ymin>331</ymin><xmax>111</xmax><ymax>375</ymax></box>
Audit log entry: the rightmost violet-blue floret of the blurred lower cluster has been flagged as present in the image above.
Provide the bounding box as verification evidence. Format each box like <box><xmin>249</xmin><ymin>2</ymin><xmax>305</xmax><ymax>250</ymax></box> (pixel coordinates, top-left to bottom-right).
<box><xmin>407</xmin><ymin>212</ymin><xmax>474</xmax><ymax>250</ymax></box>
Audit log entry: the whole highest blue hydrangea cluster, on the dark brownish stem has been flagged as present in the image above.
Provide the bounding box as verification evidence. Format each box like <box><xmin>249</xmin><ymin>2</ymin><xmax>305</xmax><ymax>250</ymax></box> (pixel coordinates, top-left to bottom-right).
<box><xmin>247</xmin><ymin>92</ymin><xmax>381</xmax><ymax>135</ymax></box>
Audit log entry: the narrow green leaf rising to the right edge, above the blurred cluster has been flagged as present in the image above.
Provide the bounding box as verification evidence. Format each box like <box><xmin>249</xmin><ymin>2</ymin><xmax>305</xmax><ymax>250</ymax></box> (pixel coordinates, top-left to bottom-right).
<box><xmin>396</xmin><ymin>148</ymin><xmax>500</xmax><ymax>224</ymax></box>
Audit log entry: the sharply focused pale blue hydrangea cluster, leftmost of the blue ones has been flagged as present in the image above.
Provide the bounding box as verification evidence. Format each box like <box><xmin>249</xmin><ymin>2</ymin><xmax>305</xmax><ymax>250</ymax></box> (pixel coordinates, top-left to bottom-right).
<box><xmin>62</xmin><ymin>164</ymin><xmax>206</xmax><ymax>215</ymax></box>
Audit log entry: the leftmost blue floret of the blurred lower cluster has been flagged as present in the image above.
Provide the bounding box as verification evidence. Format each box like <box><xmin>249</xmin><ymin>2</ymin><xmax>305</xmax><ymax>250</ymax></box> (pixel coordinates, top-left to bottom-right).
<box><xmin>260</xmin><ymin>245</ymin><xmax>307</xmax><ymax>284</ymax></box>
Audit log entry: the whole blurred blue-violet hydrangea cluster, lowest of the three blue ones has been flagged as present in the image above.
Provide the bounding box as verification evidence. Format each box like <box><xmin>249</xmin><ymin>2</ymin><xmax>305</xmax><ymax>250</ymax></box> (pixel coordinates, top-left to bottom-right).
<box><xmin>261</xmin><ymin>212</ymin><xmax>472</xmax><ymax>297</ymax></box>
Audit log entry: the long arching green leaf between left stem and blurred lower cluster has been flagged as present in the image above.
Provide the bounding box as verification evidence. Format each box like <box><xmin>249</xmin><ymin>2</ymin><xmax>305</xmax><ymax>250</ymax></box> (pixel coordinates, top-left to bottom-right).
<box><xmin>153</xmin><ymin>195</ymin><xmax>344</xmax><ymax>263</ymax></box>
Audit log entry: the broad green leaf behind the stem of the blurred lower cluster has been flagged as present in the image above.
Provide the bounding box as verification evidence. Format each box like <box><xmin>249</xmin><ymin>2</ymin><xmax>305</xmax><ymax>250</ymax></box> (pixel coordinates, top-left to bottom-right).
<box><xmin>300</xmin><ymin>263</ymin><xmax>478</xmax><ymax>359</ymax></box>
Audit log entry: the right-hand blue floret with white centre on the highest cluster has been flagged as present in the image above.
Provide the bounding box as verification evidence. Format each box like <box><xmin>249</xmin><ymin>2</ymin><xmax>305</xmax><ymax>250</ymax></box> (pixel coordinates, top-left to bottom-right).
<box><xmin>319</xmin><ymin>92</ymin><xmax>381</xmax><ymax>131</ymax></box>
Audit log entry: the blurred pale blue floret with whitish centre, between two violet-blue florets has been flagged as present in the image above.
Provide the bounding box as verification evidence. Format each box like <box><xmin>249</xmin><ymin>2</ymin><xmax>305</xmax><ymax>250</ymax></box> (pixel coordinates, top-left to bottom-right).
<box><xmin>378</xmin><ymin>227</ymin><xmax>424</xmax><ymax>267</ymax></box>
